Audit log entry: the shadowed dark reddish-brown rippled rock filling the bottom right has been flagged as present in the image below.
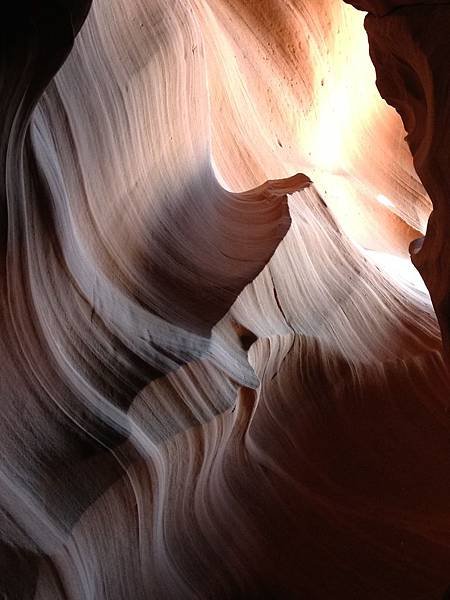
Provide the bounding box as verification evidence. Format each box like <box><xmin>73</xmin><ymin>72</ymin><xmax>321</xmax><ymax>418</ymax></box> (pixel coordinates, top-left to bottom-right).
<box><xmin>35</xmin><ymin>335</ymin><xmax>450</xmax><ymax>599</ymax></box>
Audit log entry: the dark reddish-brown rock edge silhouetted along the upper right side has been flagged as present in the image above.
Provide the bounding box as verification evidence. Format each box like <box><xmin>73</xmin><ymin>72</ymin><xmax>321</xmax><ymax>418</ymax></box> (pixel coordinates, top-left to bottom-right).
<box><xmin>348</xmin><ymin>1</ymin><xmax>450</xmax><ymax>352</ymax></box>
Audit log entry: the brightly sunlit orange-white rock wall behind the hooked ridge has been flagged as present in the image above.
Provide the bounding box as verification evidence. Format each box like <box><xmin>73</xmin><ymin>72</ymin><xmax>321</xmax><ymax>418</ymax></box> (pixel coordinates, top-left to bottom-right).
<box><xmin>201</xmin><ymin>0</ymin><xmax>431</xmax><ymax>254</ymax></box>
